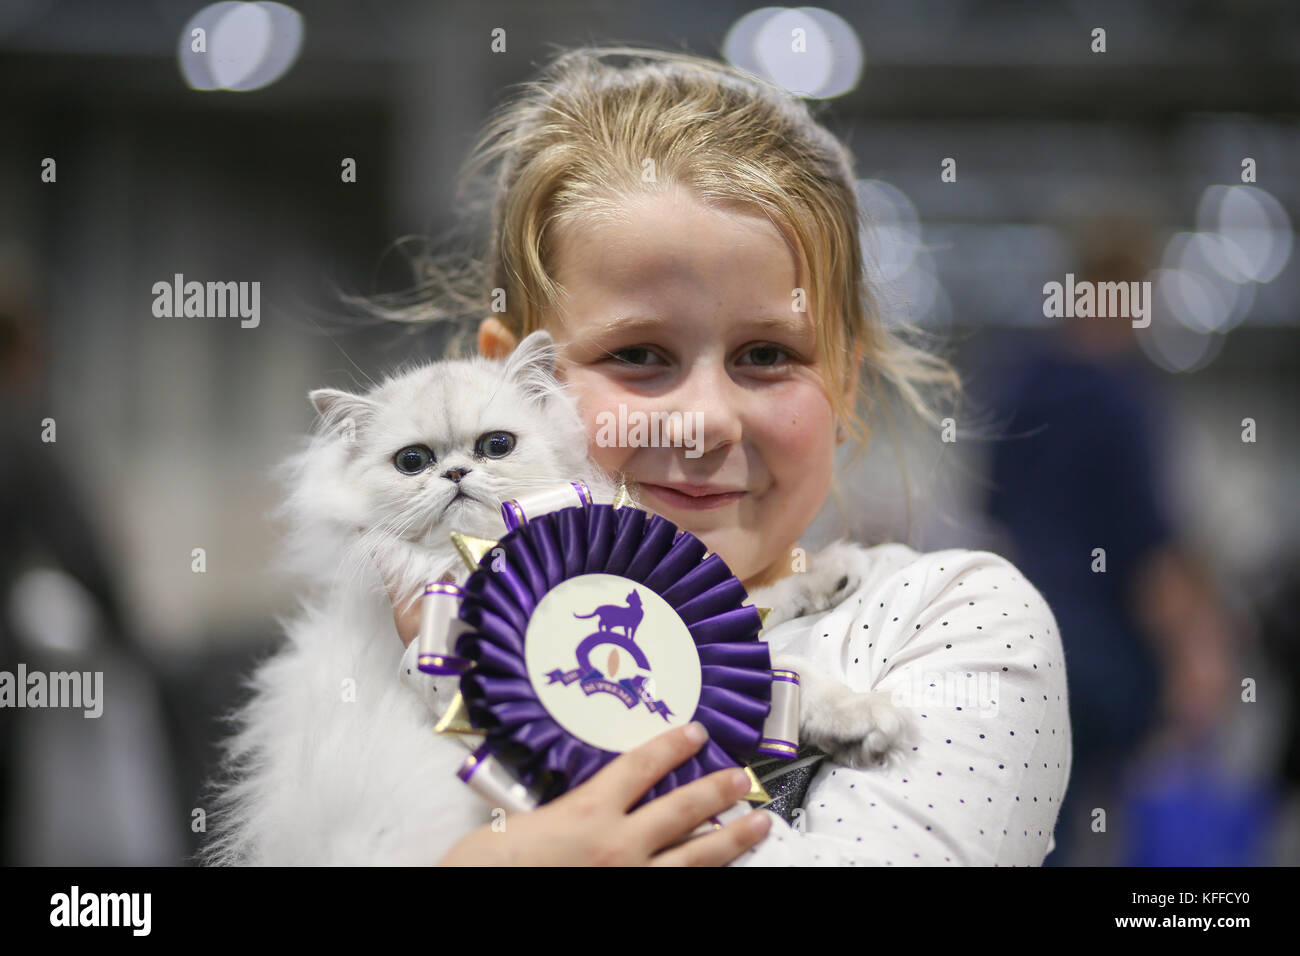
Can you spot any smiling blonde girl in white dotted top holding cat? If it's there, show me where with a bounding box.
[213,48,1070,866]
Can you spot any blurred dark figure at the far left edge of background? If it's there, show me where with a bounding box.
[0,246,179,865]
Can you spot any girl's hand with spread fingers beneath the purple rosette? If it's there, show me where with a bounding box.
[438,724,772,866]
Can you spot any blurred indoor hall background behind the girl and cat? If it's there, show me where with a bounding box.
[0,0,1300,865]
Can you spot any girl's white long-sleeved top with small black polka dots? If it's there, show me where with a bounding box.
[732,542,1071,866]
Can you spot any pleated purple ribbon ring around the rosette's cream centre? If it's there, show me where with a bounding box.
[455,505,772,805]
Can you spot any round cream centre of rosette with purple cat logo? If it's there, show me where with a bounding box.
[524,574,703,753]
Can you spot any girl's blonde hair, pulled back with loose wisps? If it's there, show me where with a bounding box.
[352,47,961,478]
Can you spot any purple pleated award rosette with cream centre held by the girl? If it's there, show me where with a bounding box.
[455,505,774,805]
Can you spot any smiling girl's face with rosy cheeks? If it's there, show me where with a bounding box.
[483,190,855,589]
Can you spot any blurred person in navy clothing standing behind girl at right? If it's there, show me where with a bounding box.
[987,202,1249,866]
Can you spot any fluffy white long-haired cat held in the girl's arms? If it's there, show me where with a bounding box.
[199,332,904,865]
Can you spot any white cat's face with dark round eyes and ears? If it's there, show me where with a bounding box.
[312,333,586,546]
